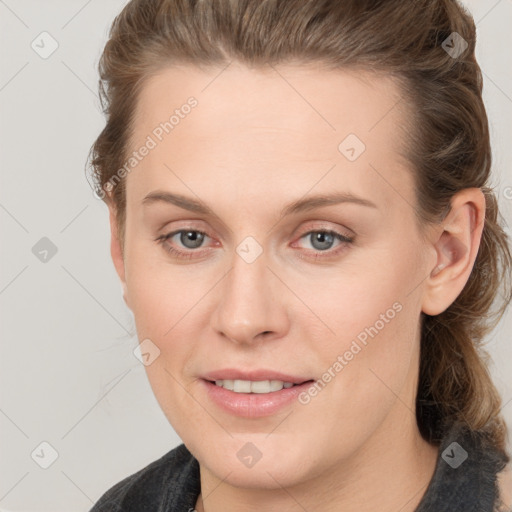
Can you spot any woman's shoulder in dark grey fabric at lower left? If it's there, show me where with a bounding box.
[90,444,200,512]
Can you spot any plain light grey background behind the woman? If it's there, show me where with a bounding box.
[0,0,512,512]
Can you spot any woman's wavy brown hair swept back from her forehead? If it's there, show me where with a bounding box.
[90,0,512,451]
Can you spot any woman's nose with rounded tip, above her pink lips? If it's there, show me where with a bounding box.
[211,246,289,345]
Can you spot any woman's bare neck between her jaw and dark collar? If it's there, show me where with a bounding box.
[196,412,438,512]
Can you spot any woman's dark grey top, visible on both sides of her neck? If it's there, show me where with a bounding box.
[90,427,509,512]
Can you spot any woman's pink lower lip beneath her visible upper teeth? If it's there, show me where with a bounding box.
[201,379,313,418]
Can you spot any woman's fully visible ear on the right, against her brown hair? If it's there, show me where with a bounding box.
[422,188,485,316]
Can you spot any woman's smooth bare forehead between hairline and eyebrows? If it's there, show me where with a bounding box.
[127,63,411,217]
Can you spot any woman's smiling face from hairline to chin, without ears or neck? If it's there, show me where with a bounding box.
[114,63,436,488]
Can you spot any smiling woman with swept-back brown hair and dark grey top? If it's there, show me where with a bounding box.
[87,0,512,512]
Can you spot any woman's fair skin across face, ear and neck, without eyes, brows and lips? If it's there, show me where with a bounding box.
[110,62,485,512]
